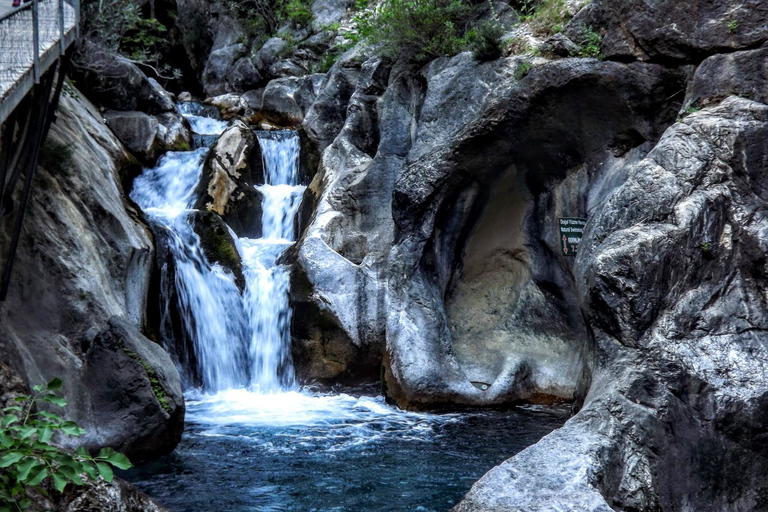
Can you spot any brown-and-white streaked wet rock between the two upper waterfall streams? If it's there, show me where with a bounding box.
[195,121,263,238]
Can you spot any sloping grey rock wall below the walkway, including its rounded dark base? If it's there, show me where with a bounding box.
[0,89,184,462]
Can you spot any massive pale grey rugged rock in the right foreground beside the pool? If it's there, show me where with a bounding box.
[455,97,768,512]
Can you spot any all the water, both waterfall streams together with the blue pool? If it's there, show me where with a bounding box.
[122,104,566,512]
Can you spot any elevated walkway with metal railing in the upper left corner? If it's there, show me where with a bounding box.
[0,0,80,123]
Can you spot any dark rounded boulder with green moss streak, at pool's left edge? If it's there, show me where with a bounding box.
[84,317,185,463]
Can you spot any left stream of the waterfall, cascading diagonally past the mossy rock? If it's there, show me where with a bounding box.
[131,126,248,390]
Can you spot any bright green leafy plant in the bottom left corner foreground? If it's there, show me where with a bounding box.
[0,379,132,512]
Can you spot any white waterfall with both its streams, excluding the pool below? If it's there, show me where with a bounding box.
[131,104,304,393]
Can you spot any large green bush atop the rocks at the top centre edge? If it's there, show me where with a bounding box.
[356,0,474,62]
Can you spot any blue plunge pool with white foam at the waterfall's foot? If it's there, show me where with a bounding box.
[123,390,567,512]
